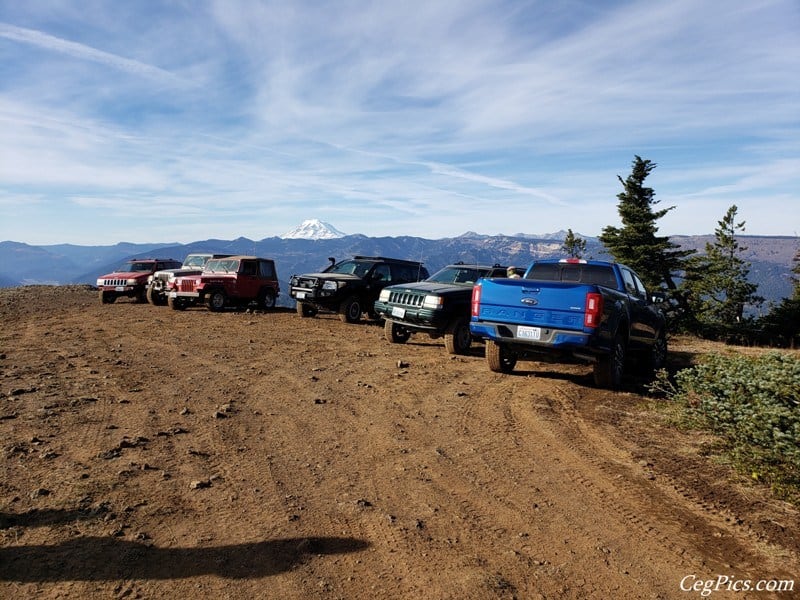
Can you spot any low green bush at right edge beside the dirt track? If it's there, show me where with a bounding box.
[670,352,800,498]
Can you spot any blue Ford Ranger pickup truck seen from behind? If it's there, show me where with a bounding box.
[470,258,667,388]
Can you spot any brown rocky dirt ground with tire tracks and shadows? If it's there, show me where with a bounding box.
[0,286,800,599]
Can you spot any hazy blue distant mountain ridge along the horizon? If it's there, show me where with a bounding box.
[0,232,800,301]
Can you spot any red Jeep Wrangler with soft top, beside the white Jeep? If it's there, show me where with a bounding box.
[167,256,280,311]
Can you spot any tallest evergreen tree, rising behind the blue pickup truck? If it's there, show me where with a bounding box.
[600,156,694,290]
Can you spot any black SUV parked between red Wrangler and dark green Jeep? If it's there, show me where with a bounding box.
[289,256,428,323]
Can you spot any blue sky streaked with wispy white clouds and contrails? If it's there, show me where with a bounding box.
[0,0,800,245]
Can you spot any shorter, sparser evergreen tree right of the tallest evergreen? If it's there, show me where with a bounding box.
[684,205,763,333]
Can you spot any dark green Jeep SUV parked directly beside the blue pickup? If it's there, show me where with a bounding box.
[374,263,523,354]
